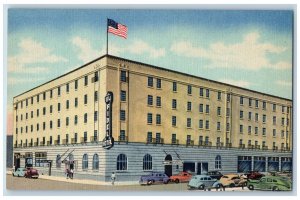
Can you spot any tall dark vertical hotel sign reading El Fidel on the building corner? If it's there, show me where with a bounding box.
[102,92,114,149]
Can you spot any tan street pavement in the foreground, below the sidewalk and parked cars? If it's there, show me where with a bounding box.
[6,175,249,193]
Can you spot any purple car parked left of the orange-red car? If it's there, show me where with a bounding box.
[139,172,170,185]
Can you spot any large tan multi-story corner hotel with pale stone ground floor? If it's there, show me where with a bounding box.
[13,55,293,181]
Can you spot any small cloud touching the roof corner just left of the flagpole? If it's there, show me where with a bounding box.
[71,36,101,63]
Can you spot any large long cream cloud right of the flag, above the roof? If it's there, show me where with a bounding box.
[170,32,291,70]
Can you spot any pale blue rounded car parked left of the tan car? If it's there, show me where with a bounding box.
[188,175,221,190]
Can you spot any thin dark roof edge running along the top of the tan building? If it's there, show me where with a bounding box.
[14,54,292,101]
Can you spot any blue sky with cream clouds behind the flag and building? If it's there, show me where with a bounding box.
[7,9,293,134]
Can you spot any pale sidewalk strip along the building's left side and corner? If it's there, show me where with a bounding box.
[6,171,139,186]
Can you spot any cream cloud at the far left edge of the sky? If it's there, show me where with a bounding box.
[8,38,68,74]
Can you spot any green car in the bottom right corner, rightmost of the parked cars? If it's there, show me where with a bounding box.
[247,176,292,191]
